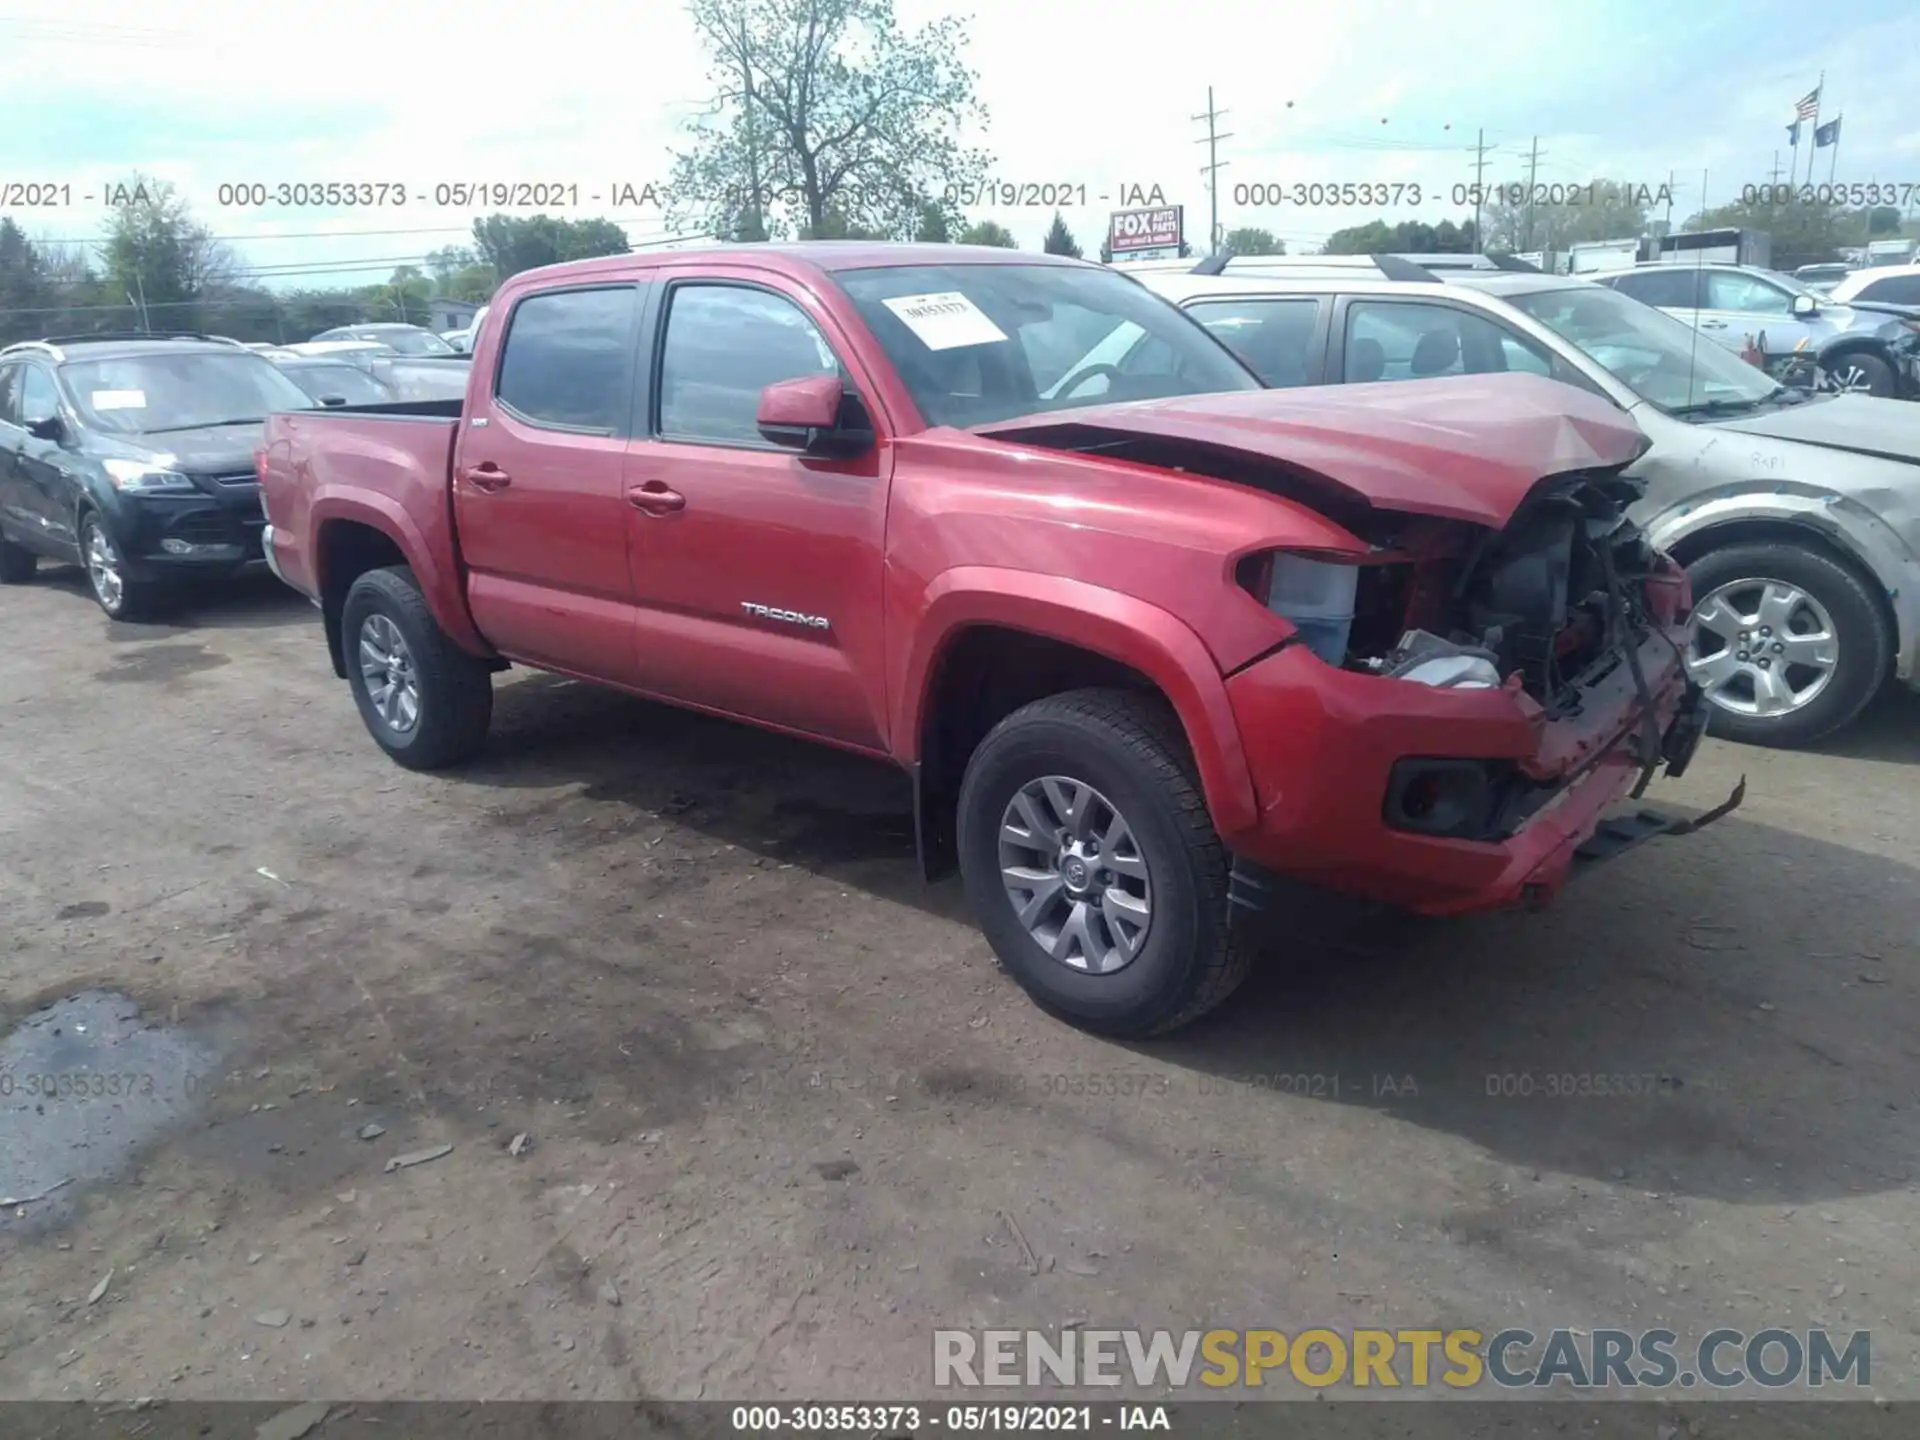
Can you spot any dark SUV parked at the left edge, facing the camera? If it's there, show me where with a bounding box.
[0,334,317,620]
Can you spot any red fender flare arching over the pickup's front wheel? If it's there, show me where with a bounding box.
[893,566,1260,835]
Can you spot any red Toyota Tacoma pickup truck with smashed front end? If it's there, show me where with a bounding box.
[247,242,1738,1035]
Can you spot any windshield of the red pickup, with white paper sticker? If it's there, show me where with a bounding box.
[835,265,1260,426]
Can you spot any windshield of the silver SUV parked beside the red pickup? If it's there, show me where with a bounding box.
[1507,286,1782,413]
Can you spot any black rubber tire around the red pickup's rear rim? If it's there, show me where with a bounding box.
[340,564,493,770]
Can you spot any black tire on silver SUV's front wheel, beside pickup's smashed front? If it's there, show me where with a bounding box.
[1688,543,1893,749]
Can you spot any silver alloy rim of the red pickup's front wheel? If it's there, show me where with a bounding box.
[1000,776,1154,975]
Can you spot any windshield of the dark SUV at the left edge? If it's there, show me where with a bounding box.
[60,349,313,436]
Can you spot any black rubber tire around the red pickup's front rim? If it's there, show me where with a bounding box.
[958,689,1254,1039]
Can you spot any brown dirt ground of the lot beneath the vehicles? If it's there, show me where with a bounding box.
[0,572,1920,1400]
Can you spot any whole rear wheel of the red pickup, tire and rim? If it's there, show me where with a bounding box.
[340,566,493,770]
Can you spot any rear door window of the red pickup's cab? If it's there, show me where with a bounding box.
[493,284,639,436]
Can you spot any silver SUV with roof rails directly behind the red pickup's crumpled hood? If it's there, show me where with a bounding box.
[1098,255,1920,745]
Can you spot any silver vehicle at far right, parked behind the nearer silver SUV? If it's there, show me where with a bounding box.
[1594,263,1920,399]
